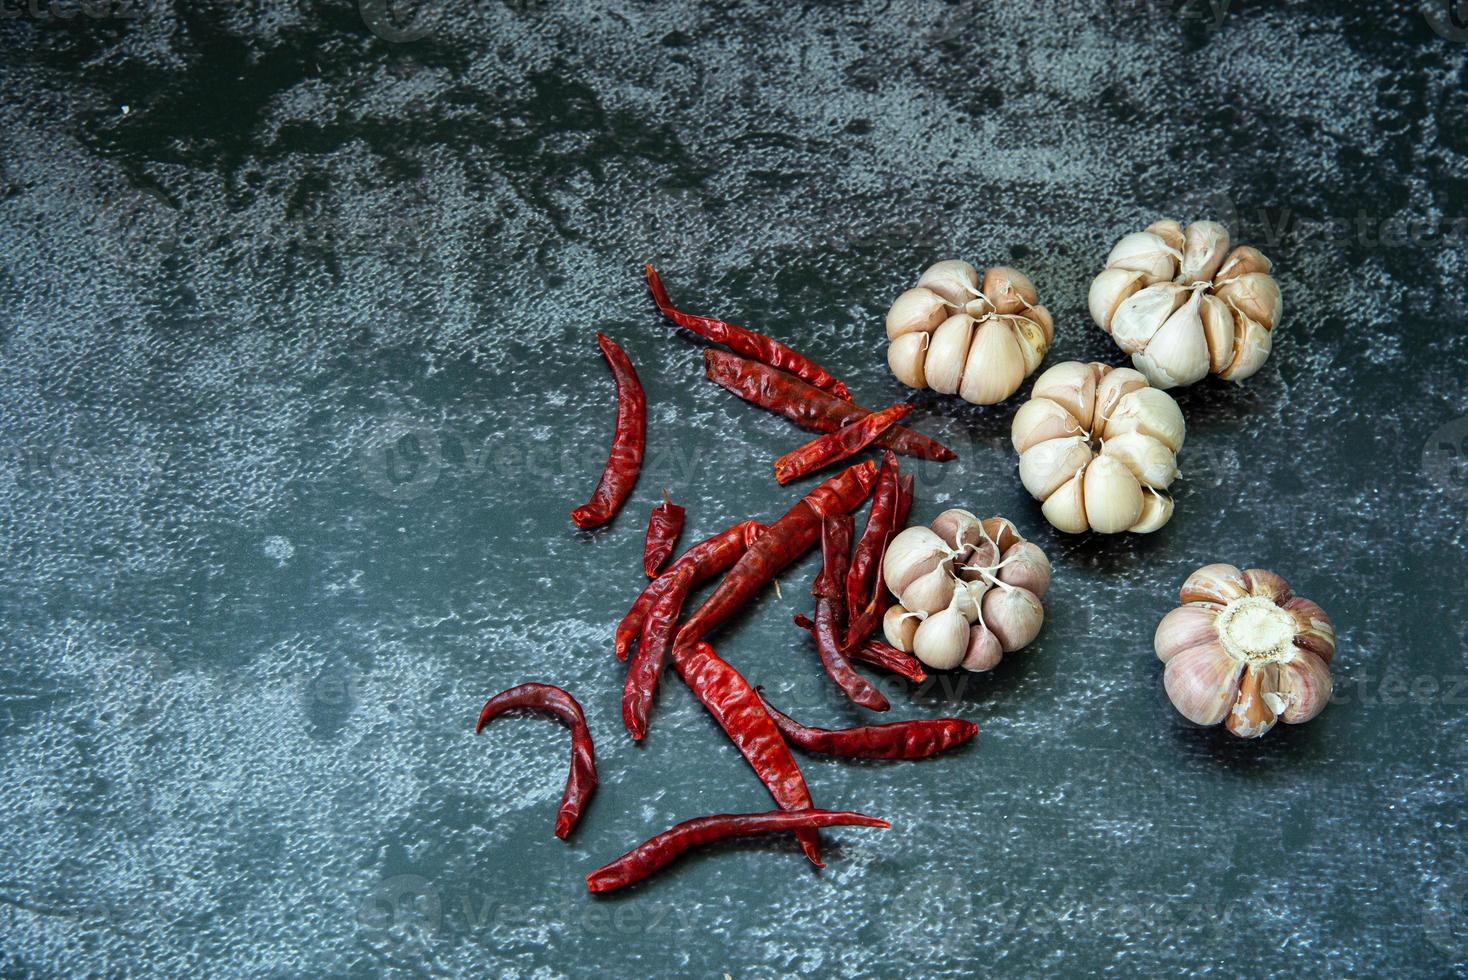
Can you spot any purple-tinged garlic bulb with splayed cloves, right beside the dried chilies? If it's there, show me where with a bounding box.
[882,510,1051,670]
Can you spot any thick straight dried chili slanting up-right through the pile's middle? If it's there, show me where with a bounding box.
[674,461,876,647]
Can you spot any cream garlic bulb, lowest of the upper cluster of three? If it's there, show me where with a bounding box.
[1010,361,1186,534]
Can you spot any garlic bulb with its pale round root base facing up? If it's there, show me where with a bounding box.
[1152,565,1336,738]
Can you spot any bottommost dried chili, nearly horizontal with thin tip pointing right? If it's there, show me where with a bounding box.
[586,810,893,892]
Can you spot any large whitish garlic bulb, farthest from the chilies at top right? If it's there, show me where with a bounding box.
[1088,222,1282,389]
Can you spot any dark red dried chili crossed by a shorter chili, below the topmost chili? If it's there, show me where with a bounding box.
[703,348,959,462]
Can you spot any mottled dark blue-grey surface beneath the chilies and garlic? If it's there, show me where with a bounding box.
[0,0,1468,977]
